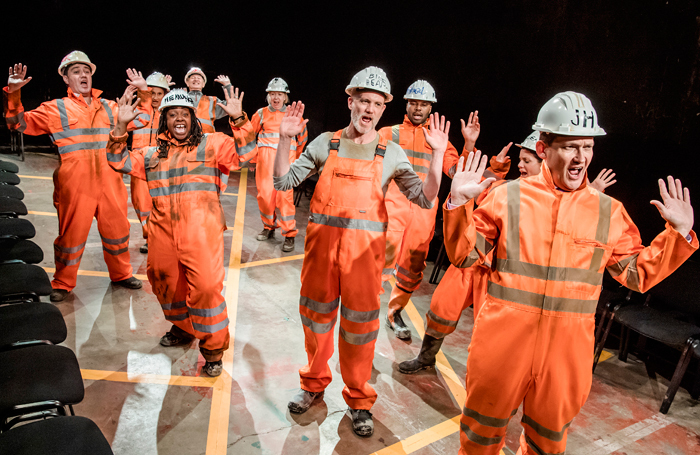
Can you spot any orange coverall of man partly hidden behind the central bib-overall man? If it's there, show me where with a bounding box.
[379,115,459,286]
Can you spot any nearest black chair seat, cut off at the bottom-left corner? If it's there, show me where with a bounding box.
[0,416,113,455]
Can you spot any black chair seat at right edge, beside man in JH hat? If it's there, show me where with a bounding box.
[615,305,700,349]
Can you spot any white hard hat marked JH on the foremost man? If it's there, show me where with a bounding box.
[532,92,606,137]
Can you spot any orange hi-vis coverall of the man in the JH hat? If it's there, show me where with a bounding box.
[444,163,698,455]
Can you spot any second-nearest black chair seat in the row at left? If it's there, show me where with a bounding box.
[0,344,85,416]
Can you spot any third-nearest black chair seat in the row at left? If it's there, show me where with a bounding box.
[0,302,67,347]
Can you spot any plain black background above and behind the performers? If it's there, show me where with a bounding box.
[5,0,700,243]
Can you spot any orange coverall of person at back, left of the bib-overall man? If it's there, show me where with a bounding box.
[232,106,309,237]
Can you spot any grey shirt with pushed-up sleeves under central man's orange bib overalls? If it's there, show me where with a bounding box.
[273,131,433,209]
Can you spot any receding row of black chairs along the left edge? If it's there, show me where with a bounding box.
[0,161,112,454]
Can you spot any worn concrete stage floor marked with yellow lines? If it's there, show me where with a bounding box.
[8,153,700,455]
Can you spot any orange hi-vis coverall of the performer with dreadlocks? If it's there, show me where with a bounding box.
[109,128,239,362]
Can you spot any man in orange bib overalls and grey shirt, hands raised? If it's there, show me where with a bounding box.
[274,66,449,436]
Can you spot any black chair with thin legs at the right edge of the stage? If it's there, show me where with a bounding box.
[593,260,700,414]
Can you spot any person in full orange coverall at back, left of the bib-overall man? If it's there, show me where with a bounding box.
[232,77,309,252]
